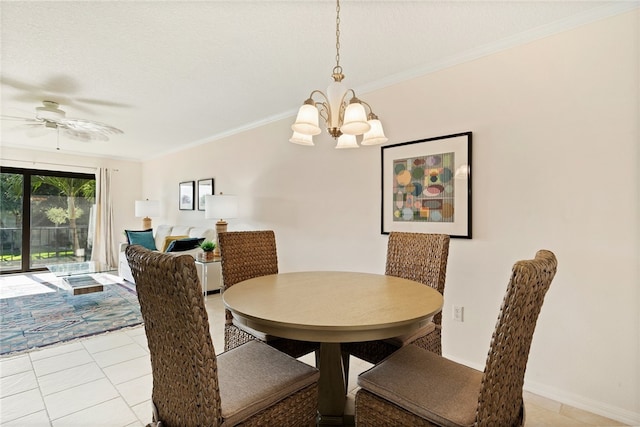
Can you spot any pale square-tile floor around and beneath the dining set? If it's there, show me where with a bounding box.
[0,294,623,427]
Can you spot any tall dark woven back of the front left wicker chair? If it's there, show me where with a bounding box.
[126,245,222,427]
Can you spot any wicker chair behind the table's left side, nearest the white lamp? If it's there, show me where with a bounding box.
[218,230,320,358]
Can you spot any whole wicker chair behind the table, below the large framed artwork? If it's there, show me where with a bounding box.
[342,232,449,364]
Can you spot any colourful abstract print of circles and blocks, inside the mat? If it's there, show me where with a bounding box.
[393,153,455,222]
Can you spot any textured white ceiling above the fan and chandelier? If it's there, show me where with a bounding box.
[0,0,638,159]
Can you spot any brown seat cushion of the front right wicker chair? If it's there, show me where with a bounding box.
[358,345,482,427]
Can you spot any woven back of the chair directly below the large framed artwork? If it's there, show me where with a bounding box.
[385,232,449,325]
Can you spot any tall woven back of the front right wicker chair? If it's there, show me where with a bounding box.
[477,250,558,426]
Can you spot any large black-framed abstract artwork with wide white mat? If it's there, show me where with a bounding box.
[381,132,471,239]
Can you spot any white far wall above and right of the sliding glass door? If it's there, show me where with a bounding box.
[0,147,142,257]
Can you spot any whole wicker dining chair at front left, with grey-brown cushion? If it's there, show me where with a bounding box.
[126,245,319,427]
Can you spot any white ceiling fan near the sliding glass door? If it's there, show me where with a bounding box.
[1,101,123,141]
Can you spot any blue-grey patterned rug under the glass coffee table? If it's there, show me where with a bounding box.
[0,274,142,355]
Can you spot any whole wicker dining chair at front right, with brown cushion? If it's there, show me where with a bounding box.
[356,250,557,427]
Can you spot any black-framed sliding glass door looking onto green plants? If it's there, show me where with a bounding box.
[0,168,96,273]
